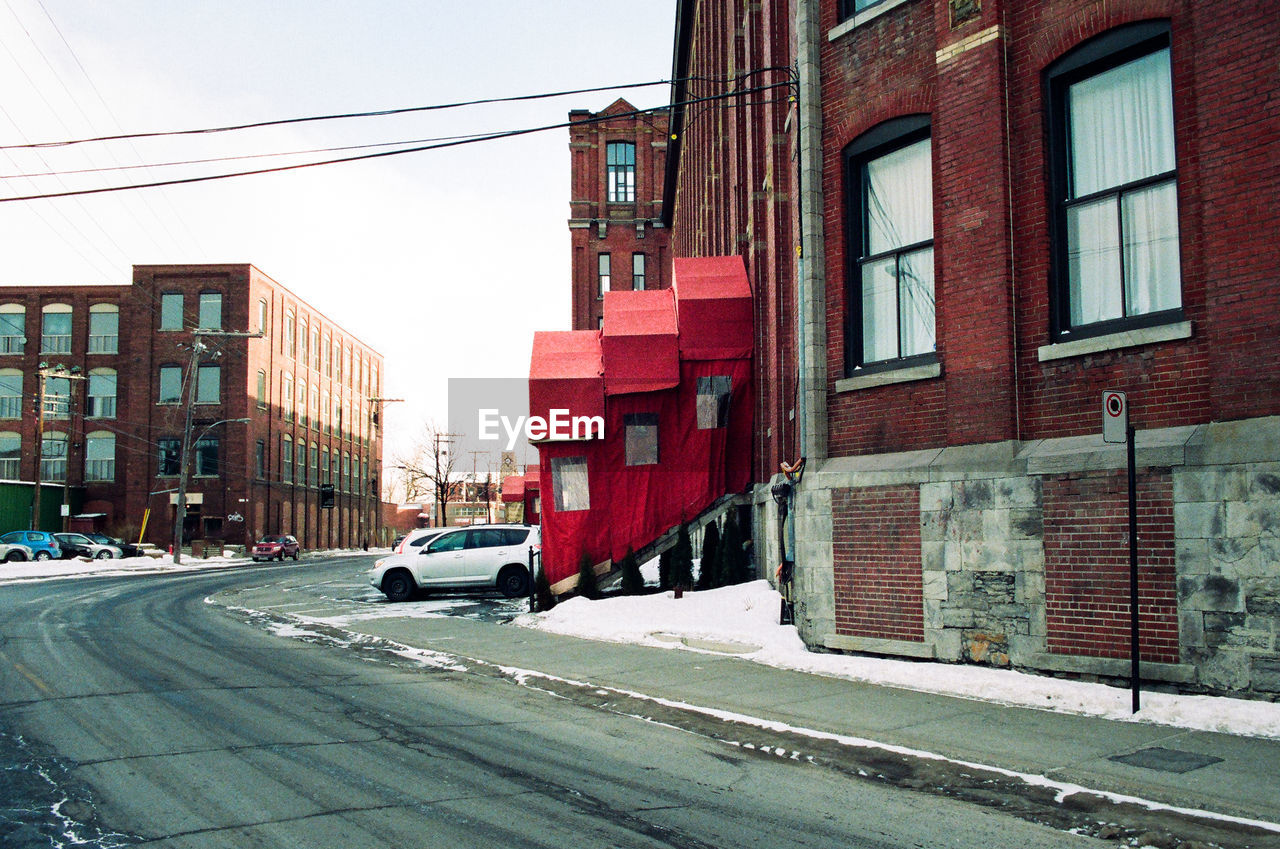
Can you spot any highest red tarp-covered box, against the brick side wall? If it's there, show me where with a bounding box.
[672,256,754,360]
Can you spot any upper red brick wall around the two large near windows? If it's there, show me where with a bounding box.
[820,0,1280,456]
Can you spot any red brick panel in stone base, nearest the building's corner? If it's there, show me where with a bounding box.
[832,487,924,642]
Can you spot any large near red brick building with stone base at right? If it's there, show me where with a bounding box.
[666,0,1280,697]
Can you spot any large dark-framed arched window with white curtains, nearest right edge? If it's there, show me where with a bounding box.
[1046,20,1183,342]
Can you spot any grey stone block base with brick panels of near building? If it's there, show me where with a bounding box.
[794,417,1280,699]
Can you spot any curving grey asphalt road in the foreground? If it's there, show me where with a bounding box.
[0,558,1105,849]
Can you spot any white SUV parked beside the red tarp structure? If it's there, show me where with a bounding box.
[369,525,541,602]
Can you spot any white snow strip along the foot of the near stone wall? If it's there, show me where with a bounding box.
[516,580,1280,738]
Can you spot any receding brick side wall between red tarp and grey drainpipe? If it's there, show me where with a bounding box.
[663,0,808,483]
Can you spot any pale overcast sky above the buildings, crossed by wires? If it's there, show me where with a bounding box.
[0,0,675,491]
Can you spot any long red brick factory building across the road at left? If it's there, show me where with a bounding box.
[0,265,383,558]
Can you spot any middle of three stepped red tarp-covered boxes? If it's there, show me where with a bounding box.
[600,289,680,394]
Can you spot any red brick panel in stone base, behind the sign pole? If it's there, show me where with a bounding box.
[1043,469,1179,663]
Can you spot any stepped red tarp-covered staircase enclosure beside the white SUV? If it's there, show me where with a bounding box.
[526,257,754,592]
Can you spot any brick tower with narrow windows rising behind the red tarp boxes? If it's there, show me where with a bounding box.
[568,100,671,330]
